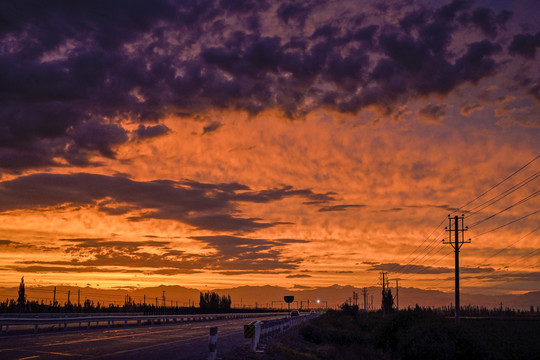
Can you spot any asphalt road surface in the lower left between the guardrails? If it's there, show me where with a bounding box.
[0,314,283,360]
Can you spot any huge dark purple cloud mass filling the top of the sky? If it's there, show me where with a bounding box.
[0,0,539,171]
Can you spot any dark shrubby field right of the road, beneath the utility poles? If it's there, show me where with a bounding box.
[224,309,540,360]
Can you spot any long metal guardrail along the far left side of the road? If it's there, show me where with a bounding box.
[0,313,276,335]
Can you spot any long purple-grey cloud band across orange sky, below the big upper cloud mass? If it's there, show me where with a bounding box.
[0,173,331,232]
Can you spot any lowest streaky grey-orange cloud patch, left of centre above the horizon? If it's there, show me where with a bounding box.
[13,235,307,275]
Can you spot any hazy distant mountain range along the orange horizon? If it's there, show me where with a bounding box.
[0,285,540,309]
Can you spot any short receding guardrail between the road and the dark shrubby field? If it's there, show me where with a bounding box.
[244,314,318,351]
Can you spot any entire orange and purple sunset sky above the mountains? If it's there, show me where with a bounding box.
[0,0,540,293]
